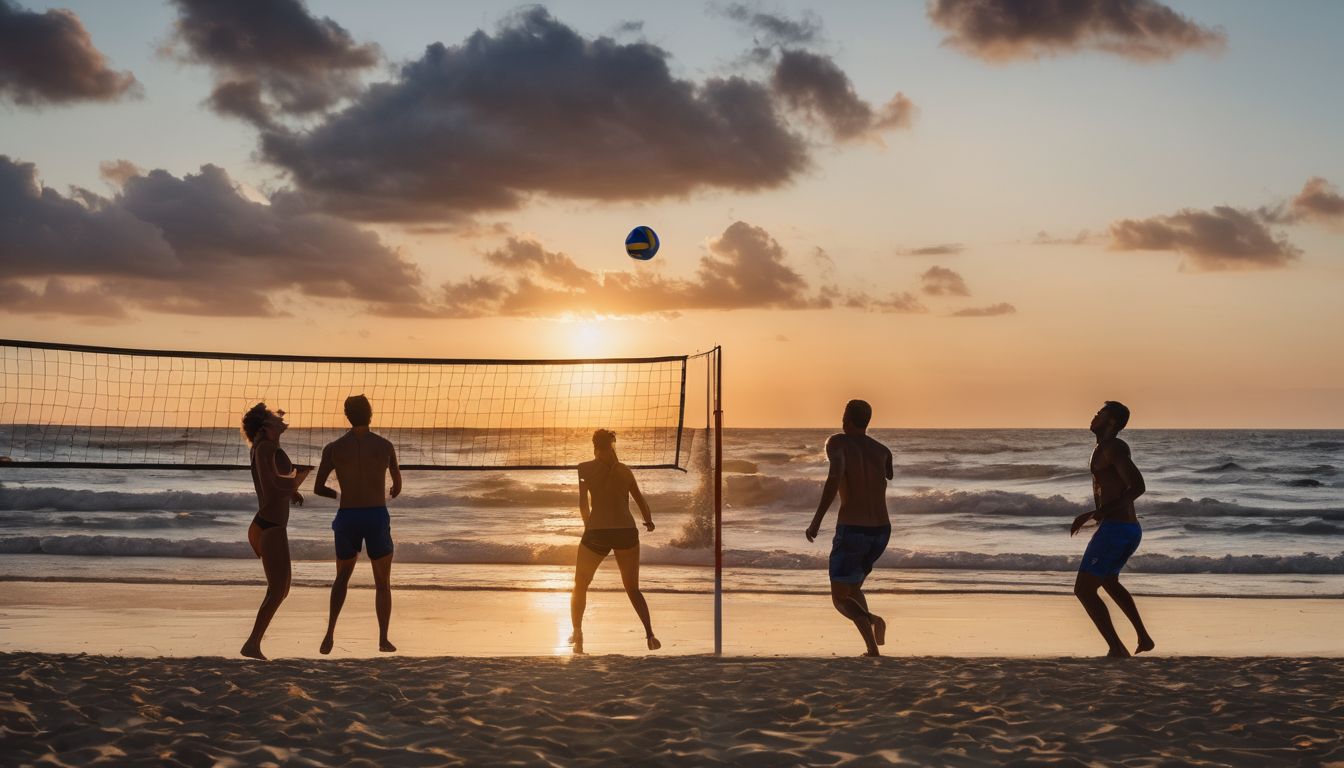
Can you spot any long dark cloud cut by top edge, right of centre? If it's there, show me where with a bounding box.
[929,0,1227,62]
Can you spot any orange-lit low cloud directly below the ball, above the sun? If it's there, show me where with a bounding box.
[408,222,832,317]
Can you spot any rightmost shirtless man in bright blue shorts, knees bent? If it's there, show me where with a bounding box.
[1068,401,1154,656]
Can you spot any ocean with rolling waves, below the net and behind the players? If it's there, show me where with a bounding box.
[0,429,1344,599]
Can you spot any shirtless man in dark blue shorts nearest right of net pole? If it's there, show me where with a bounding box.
[805,399,894,656]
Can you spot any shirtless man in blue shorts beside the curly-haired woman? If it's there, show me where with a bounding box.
[313,394,402,654]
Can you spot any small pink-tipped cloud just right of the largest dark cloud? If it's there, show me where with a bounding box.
[770,48,914,141]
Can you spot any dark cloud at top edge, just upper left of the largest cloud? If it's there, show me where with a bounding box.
[172,0,379,126]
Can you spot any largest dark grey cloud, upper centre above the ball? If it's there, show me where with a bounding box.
[261,8,860,222]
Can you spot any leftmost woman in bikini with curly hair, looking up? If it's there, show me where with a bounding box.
[241,402,312,659]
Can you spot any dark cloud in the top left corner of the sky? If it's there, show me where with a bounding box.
[0,0,141,106]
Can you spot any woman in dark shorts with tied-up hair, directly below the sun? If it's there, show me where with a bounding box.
[570,429,663,654]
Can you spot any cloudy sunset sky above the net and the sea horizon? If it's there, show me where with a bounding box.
[0,0,1344,428]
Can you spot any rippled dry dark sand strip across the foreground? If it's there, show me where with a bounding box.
[0,654,1344,767]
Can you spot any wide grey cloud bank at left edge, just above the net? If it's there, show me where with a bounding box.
[0,156,421,316]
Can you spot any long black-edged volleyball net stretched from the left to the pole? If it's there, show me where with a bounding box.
[0,340,718,469]
